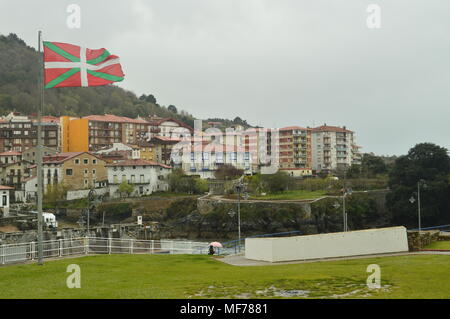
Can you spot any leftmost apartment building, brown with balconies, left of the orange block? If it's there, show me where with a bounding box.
[0,112,59,152]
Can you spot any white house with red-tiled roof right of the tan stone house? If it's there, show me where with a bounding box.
[106,159,172,197]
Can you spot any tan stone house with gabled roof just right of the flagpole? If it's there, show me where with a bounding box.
[43,152,108,190]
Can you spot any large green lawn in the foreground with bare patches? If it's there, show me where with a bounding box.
[0,255,450,298]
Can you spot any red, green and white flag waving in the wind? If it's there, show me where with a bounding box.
[43,41,124,89]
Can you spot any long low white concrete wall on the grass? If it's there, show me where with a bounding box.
[245,227,408,262]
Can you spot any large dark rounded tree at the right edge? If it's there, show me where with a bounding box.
[386,143,450,227]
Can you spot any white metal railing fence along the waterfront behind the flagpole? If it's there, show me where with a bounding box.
[0,237,209,265]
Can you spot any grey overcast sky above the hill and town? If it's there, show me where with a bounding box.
[0,0,450,154]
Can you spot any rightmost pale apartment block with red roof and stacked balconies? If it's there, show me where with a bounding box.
[311,124,360,172]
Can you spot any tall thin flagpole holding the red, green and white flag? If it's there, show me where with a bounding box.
[36,31,44,265]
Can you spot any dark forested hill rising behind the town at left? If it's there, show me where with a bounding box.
[0,34,199,126]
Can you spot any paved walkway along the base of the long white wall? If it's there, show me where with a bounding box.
[217,251,450,266]
